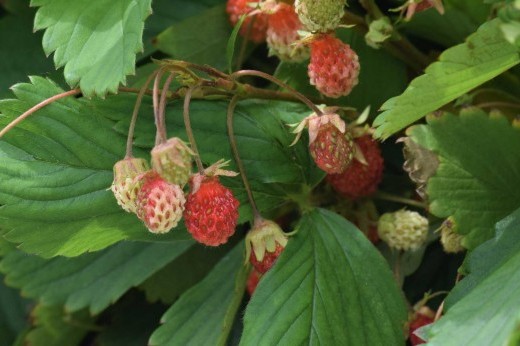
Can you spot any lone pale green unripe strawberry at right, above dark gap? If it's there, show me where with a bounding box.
[377,210,428,251]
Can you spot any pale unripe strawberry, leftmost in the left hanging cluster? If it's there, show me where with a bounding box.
[110,157,150,213]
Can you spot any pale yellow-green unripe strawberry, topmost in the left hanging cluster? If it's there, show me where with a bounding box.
[151,137,193,187]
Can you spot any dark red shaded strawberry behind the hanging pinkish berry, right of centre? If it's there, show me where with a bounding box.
[327,135,384,199]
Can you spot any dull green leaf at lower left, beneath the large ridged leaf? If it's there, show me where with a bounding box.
[0,241,193,314]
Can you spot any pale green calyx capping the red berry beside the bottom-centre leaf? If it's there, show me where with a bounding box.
[246,219,287,263]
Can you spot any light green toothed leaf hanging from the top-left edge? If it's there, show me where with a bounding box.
[31,0,151,97]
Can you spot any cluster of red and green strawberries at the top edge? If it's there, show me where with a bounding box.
[227,0,359,98]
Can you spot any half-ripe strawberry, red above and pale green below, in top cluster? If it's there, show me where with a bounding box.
[267,3,309,62]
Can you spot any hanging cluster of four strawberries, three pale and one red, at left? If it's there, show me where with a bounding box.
[111,138,239,246]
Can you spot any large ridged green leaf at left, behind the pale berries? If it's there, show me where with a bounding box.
[0,77,190,257]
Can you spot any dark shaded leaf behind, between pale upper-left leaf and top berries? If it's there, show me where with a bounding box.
[155,5,231,68]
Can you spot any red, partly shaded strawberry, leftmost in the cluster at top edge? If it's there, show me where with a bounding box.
[226,0,267,43]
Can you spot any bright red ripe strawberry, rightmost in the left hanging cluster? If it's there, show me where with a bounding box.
[184,175,239,246]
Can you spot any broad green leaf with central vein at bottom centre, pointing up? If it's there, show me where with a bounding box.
[241,209,407,345]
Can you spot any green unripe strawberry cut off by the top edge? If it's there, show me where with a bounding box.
[295,0,346,32]
